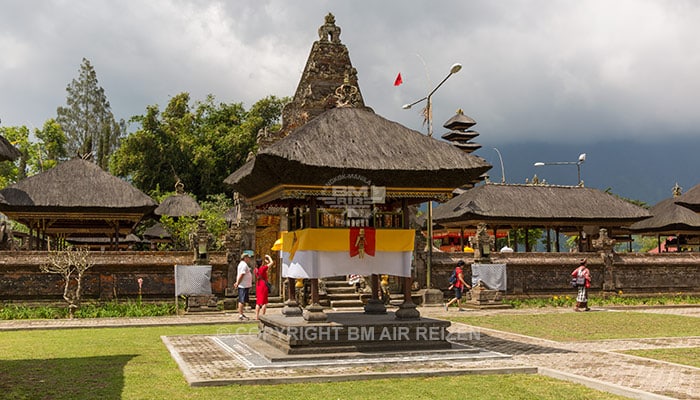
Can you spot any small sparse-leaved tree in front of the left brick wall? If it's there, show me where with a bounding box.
[39,249,94,318]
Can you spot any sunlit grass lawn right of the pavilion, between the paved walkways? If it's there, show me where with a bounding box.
[450,311,700,341]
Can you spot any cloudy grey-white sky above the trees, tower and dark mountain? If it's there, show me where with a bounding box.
[0,0,700,177]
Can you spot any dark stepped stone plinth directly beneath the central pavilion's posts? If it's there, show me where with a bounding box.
[258,312,454,355]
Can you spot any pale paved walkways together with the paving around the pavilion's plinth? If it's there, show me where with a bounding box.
[0,307,700,400]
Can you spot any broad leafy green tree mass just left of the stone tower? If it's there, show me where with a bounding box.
[110,93,288,199]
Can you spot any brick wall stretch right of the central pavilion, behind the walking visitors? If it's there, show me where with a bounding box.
[416,253,700,295]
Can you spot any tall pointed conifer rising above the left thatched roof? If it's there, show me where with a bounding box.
[56,58,125,169]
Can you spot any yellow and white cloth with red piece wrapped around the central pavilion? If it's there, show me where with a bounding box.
[282,228,415,278]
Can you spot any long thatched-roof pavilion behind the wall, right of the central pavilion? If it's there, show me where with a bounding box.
[433,183,651,252]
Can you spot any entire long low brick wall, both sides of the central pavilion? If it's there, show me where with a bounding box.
[0,251,700,301]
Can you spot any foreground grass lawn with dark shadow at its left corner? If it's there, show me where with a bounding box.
[0,325,621,400]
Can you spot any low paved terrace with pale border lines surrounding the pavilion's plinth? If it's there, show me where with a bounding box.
[162,334,520,386]
